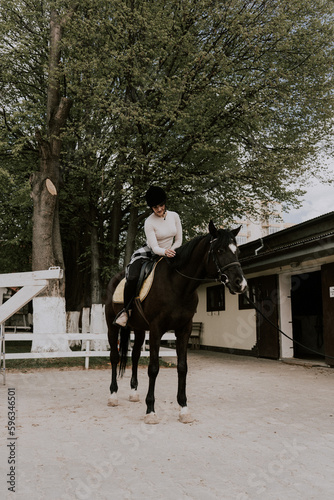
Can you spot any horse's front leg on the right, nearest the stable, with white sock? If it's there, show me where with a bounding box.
[175,324,194,424]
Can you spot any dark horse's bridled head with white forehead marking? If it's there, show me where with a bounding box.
[208,221,247,294]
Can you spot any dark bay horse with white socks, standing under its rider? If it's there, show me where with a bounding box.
[106,221,247,424]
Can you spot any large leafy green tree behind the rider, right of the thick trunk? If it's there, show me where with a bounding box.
[62,0,333,284]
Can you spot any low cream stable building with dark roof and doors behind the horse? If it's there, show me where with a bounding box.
[194,212,334,366]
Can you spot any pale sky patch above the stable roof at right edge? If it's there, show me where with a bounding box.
[283,158,334,224]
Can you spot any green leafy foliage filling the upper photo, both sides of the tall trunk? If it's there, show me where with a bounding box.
[0,0,334,300]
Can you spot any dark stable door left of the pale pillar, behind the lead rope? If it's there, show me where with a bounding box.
[252,275,280,359]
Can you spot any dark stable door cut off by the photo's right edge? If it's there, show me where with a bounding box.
[321,263,334,366]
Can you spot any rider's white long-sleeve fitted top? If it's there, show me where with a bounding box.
[144,210,182,255]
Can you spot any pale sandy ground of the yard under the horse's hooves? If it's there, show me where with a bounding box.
[0,351,334,500]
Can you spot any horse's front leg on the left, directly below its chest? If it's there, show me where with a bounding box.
[144,330,160,424]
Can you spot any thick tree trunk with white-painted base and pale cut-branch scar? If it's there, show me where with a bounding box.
[30,7,71,351]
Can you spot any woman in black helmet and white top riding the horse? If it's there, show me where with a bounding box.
[114,186,182,327]
